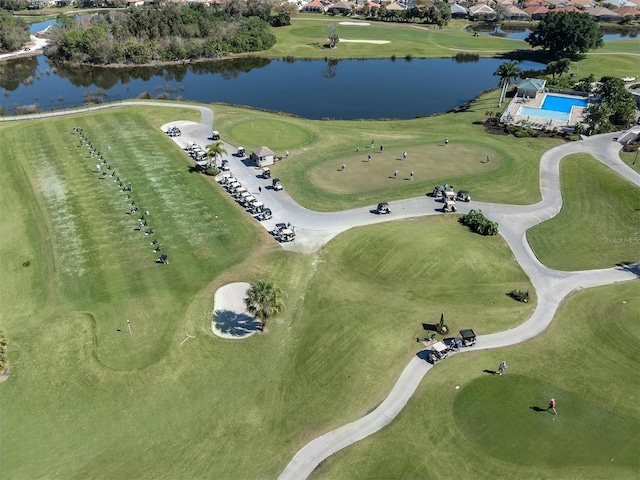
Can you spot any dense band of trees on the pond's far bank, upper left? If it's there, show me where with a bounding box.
[46,0,290,65]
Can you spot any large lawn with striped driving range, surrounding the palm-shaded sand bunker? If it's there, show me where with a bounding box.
[0,106,531,479]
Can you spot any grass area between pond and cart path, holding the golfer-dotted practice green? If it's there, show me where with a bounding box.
[215,92,562,211]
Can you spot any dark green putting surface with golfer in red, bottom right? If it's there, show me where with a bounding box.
[453,376,640,467]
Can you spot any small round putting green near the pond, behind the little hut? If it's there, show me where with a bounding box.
[228,117,314,155]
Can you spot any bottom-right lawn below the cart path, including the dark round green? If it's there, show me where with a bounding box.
[313,282,640,479]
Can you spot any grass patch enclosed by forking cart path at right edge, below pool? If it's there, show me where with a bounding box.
[527,154,640,270]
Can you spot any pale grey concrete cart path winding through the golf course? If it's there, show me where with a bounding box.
[5,101,640,480]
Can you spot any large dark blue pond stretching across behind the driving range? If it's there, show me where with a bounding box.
[0,56,544,120]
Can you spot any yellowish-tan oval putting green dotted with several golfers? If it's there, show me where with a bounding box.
[309,143,502,194]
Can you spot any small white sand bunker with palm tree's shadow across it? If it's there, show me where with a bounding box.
[211,282,261,339]
